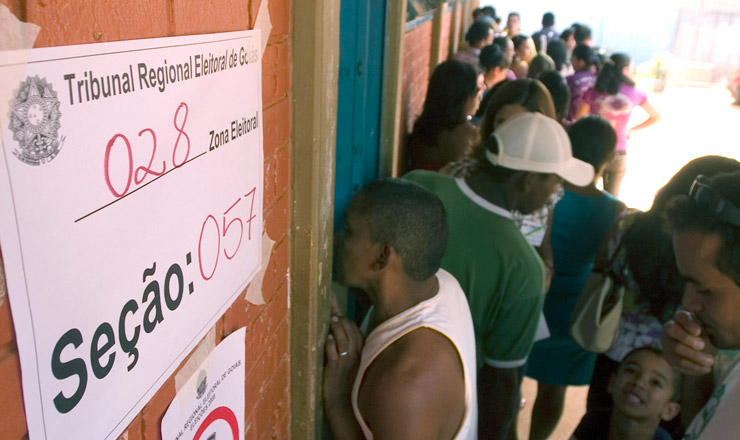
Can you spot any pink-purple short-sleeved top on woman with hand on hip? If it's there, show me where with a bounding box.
[583,83,647,152]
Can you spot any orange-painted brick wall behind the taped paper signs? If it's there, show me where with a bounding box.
[0,0,292,440]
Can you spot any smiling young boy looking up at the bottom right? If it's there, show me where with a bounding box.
[572,347,681,440]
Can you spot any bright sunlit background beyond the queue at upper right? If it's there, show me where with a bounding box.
[481,0,740,213]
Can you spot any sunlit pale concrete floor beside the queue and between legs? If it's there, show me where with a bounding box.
[517,83,740,440]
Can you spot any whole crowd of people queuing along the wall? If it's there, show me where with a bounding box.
[323,7,740,440]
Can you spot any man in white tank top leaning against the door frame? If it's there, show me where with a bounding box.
[324,179,478,440]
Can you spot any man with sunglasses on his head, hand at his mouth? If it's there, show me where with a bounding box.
[663,173,740,440]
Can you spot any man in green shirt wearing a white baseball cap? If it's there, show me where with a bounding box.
[405,112,594,439]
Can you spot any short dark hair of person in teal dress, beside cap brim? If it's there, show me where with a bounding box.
[568,115,617,172]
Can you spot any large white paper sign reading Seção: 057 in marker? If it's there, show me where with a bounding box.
[0,31,263,439]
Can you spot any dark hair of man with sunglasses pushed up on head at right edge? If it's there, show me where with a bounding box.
[665,171,740,286]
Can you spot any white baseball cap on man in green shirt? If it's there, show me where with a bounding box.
[486,112,594,186]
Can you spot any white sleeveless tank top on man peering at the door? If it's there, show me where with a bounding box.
[352,269,478,440]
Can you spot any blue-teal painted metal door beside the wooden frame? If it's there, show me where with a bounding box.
[334,0,387,229]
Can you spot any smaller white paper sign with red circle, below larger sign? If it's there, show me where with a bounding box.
[162,327,246,440]
